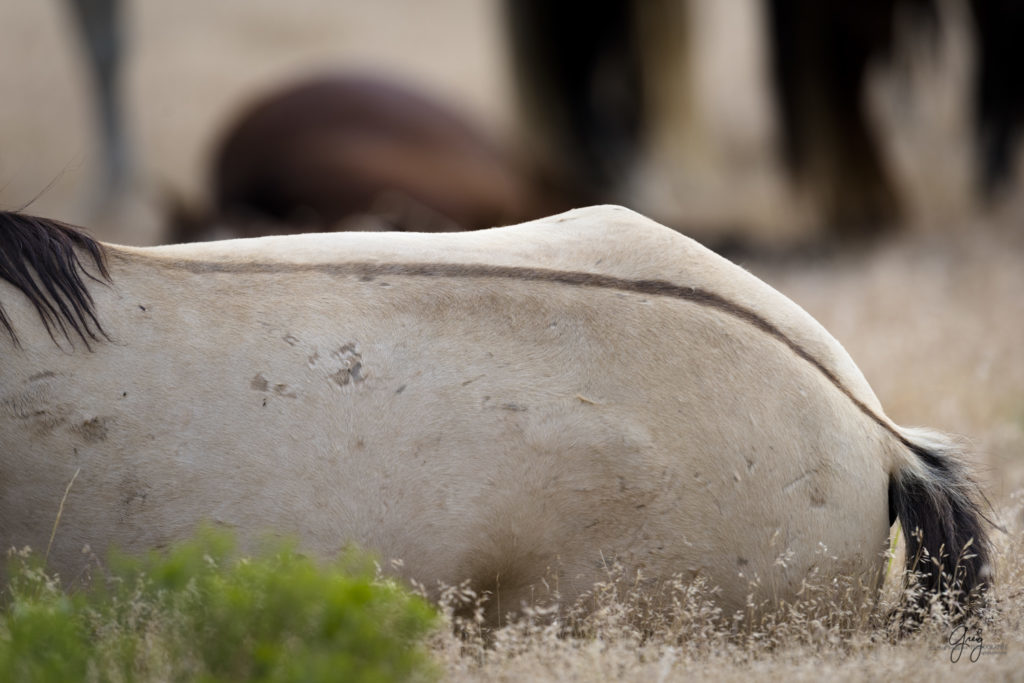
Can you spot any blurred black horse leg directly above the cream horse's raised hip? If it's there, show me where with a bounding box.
[505,0,644,209]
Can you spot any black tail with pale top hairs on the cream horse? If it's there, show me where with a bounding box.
[889,428,993,614]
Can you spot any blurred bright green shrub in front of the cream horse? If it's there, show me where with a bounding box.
[0,530,437,681]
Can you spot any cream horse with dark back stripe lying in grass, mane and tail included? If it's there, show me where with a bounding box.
[0,207,987,613]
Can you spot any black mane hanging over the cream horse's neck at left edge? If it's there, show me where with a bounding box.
[0,211,110,348]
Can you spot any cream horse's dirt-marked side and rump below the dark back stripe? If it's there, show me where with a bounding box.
[0,254,888,608]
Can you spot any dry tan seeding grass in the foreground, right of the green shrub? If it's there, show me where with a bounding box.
[433,501,1024,681]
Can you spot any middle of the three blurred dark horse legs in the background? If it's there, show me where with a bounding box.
[768,0,919,238]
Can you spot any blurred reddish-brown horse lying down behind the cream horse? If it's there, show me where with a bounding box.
[170,76,567,242]
